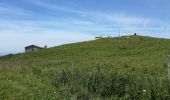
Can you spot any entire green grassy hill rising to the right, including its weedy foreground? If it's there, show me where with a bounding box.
[0,36,170,100]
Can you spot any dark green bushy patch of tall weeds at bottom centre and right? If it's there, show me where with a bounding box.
[54,66,170,100]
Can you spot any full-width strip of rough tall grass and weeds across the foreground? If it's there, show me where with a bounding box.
[0,62,170,100]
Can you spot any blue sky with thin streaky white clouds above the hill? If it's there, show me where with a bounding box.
[0,0,170,55]
